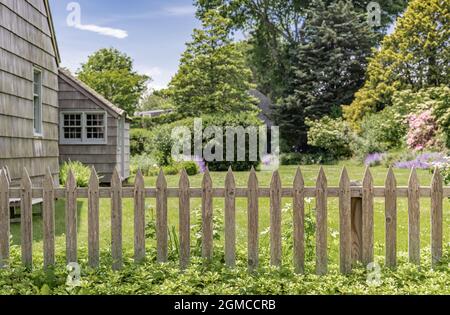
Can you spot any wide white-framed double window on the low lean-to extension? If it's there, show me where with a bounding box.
[61,112,106,144]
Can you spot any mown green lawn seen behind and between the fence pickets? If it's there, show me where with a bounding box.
[7,162,450,263]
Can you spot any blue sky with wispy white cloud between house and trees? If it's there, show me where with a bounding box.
[50,0,200,89]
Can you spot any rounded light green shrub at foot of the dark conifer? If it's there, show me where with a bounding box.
[306,116,353,159]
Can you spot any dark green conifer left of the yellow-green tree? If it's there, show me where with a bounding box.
[274,0,376,149]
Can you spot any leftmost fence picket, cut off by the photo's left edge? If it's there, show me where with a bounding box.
[0,170,10,268]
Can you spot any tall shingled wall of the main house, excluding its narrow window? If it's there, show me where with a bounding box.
[0,0,59,182]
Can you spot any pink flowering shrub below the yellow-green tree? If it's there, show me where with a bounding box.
[406,110,439,151]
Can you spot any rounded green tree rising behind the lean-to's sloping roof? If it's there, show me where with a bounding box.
[77,48,150,116]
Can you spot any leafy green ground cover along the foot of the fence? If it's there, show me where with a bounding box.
[0,199,450,295]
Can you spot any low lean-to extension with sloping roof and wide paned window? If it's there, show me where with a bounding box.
[58,69,130,183]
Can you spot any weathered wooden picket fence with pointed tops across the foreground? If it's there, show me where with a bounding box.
[0,168,444,275]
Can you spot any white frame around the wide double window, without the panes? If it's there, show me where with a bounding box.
[59,110,108,145]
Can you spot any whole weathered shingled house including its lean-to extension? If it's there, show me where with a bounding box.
[0,0,130,185]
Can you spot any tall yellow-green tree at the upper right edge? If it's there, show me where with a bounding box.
[344,0,450,129]
